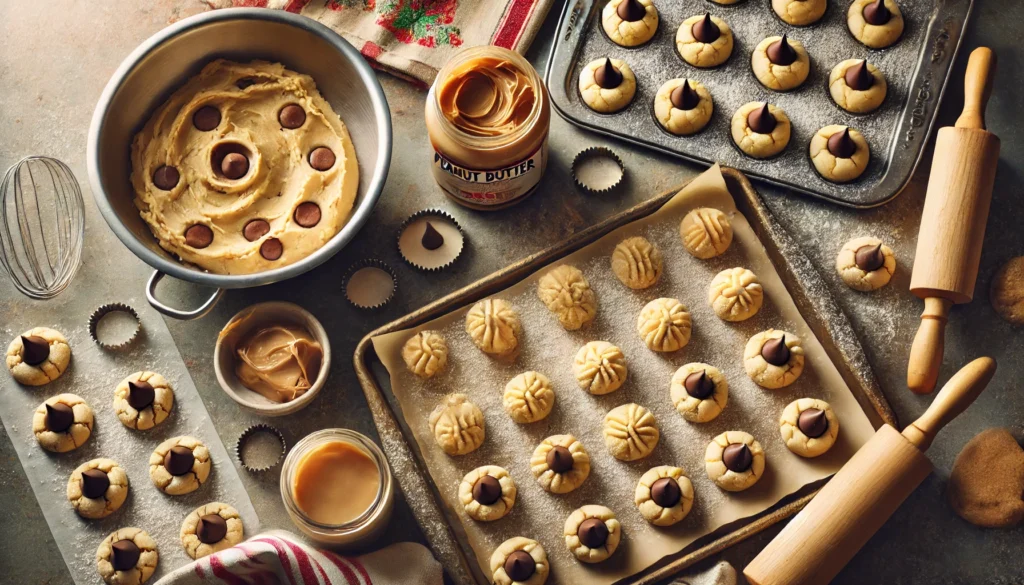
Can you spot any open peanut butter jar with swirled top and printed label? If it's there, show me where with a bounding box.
[426,46,551,209]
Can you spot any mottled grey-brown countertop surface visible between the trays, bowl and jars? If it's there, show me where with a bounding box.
[0,0,1024,584]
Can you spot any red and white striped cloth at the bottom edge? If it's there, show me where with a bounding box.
[157,531,442,585]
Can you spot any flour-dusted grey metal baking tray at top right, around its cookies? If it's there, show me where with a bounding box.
[545,0,974,208]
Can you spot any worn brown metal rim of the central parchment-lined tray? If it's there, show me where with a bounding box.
[354,168,897,585]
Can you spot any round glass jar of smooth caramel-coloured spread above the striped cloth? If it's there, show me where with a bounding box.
[281,428,394,545]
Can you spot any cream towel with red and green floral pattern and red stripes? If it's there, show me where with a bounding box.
[206,0,552,87]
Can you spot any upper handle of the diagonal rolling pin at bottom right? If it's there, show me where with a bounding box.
[903,358,995,451]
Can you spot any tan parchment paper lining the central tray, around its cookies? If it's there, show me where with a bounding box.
[373,166,874,584]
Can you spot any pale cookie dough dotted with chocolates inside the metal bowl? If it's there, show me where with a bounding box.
[131,59,358,275]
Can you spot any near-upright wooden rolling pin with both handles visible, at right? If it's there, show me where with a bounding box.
[906,47,999,393]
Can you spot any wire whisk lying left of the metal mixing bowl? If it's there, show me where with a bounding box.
[0,156,85,299]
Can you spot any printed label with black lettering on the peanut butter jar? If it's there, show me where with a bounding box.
[432,140,548,206]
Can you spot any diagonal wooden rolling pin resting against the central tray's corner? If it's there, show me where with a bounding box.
[743,358,995,585]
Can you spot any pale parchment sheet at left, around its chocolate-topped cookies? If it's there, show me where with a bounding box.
[0,305,259,585]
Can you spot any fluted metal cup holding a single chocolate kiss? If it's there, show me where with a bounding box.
[397,209,466,273]
